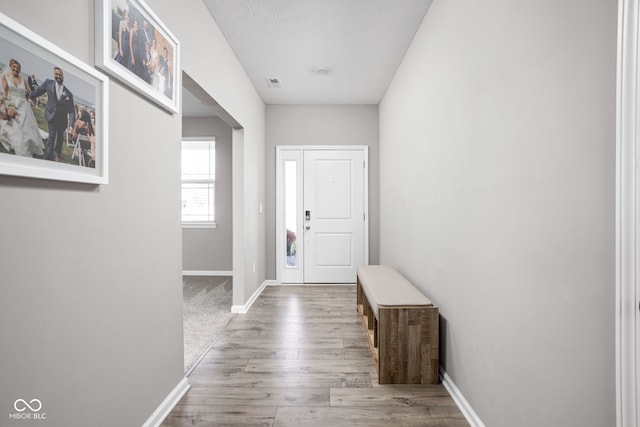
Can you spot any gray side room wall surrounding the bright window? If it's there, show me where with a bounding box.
[182,117,233,271]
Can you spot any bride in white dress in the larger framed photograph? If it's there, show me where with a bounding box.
[0,59,44,157]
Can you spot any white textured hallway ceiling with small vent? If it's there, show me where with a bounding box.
[203,0,431,104]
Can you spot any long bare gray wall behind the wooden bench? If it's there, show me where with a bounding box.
[380,0,617,427]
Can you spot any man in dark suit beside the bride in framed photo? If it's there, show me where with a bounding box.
[29,67,76,162]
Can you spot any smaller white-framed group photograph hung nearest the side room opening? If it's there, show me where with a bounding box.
[95,0,181,113]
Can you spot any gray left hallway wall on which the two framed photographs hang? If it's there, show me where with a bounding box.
[0,0,265,426]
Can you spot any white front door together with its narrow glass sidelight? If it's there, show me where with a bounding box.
[276,146,368,283]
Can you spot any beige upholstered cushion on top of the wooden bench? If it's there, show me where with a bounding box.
[358,265,433,317]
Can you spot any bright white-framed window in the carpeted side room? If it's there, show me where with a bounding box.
[182,139,216,227]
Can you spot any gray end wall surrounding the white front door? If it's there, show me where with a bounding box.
[265,105,380,279]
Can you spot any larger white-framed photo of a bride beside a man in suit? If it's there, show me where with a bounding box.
[0,13,109,184]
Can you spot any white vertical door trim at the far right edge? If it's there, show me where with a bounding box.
[615,0,640,427]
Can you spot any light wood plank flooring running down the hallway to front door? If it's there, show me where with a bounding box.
[162,285,468,427]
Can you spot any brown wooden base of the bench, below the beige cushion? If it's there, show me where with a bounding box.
[357,280,440,384]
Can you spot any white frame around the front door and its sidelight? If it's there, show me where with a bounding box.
[276,145,369,284]
